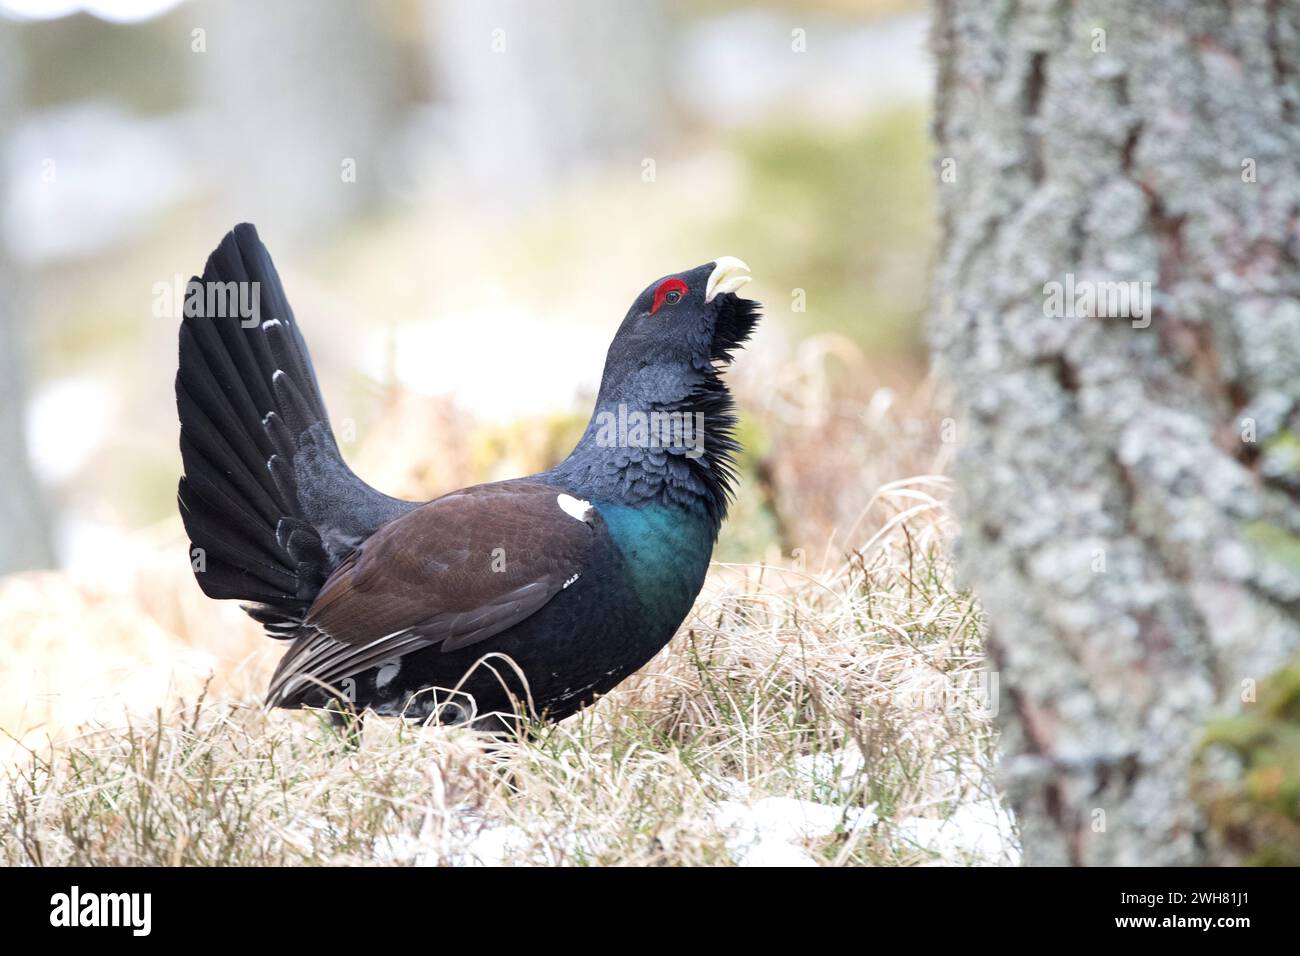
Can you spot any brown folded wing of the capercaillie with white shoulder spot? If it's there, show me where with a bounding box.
[268,481,602,704]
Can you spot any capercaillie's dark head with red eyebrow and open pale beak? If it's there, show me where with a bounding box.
[601,256,759,408]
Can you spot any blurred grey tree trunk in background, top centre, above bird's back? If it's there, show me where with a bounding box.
[426,0,675,206]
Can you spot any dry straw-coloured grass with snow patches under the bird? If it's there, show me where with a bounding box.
[0,479,1014,865]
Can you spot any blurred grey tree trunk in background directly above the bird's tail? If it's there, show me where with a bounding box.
[189,0,400,239]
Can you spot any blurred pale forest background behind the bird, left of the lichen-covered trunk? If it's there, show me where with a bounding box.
[0,0,943,754]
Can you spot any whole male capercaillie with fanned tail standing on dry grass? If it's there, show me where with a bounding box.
[176,224,759,730]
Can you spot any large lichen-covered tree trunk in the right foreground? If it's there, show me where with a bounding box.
[931,0,1300,865]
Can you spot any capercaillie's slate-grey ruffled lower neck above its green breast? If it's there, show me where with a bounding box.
[545,377,740,537]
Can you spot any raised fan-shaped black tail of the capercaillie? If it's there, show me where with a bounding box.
[176,224,413,637]
